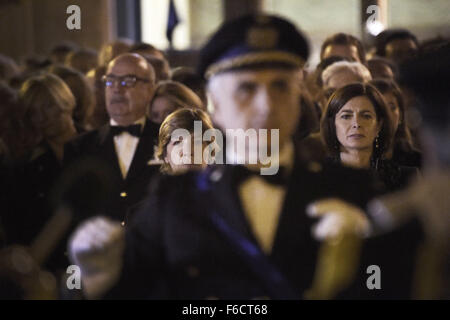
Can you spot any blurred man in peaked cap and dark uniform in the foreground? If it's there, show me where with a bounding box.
[69,15,382,299]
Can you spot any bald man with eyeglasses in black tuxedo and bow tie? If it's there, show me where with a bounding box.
[64,53,159,224]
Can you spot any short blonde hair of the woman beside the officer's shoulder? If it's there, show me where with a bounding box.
[156,108,214,173]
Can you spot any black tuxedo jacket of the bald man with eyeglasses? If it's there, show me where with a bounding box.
[64,119,159,221]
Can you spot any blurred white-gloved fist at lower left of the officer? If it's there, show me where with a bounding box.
[69,217,125,299]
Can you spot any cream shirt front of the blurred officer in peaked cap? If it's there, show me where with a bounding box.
[239,143,295,254]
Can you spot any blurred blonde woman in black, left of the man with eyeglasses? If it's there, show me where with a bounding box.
[8,74,76,251]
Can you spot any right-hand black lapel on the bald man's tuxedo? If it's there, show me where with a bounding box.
[126,119,159,180]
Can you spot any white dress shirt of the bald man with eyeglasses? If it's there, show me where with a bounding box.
[110,117,145,179]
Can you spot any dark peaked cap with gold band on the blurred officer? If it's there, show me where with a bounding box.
[198,16,309,78]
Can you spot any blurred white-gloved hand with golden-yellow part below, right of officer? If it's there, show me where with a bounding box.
[305,198,370,299]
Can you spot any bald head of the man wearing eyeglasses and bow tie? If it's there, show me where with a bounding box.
[105,53,155,125]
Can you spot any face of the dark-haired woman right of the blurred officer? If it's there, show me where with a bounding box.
[335,96,381,150]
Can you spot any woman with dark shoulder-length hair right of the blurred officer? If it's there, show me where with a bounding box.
[320,83,412,191]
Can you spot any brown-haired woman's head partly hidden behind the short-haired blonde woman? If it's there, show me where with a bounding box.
[149,81,205,124]
